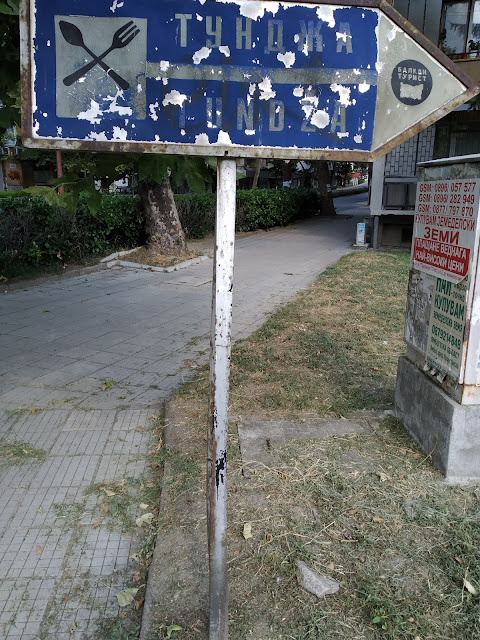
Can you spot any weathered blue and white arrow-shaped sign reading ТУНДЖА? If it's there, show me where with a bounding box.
[23,0,475,159]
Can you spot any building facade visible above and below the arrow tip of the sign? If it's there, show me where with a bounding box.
[370,0,480,248]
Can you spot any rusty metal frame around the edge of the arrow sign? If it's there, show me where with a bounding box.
[20,0,480,162]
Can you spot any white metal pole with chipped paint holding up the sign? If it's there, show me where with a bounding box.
[207,158,237,640]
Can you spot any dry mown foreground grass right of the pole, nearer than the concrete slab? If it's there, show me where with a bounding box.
[229,419,480,640]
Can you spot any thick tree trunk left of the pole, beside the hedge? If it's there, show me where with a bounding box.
[138,178,188,256]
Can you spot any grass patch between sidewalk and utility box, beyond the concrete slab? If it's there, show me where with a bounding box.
[230,253,409,416]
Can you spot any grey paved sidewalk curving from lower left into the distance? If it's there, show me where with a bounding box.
[0,212,357,640]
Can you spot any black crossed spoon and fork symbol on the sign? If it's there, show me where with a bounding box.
[59,20,140,91]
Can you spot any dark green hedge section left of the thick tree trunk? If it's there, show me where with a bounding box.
[0,192,144,274]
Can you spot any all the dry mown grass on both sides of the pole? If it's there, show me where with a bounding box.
[159,252,480,640]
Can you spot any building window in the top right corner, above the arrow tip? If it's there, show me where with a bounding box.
[439,0,480,58]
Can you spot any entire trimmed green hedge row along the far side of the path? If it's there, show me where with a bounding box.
[0,189,319,274]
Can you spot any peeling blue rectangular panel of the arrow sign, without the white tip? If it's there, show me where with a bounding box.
[34,0,378,149]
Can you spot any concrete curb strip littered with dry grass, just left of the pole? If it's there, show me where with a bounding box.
[140,397,208,640]
